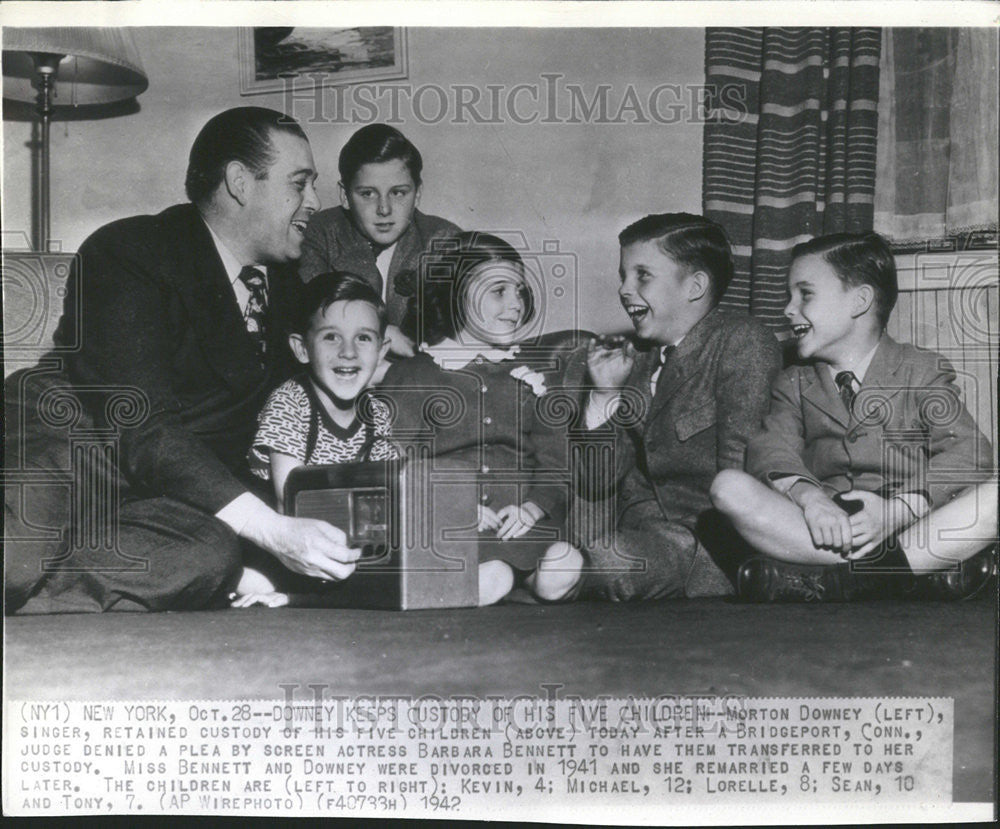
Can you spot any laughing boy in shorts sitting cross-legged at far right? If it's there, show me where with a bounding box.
[712,233,997,601]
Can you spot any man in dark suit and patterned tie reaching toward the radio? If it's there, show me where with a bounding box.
[5,107,358,613]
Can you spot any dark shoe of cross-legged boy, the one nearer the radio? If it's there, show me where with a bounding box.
[736,556,848,602]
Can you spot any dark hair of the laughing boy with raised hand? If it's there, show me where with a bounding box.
[618,213,733,305]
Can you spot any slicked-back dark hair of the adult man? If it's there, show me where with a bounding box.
[184,107,308,205]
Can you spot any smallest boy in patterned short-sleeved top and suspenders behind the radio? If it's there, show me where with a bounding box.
[233,272,397,607]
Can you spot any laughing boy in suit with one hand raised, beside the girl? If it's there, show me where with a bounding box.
[580,213,780,601]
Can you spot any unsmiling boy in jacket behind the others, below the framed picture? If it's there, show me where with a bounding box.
[299,124,460,357]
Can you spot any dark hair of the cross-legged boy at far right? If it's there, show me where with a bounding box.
[792,231,899,328]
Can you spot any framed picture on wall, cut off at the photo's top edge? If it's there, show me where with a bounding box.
[239,26,407,95]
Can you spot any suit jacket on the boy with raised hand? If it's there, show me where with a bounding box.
[588,308,781,529]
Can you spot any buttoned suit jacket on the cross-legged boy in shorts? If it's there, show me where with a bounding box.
[747,335,993,505]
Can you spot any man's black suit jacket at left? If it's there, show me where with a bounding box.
[47,204,301,513]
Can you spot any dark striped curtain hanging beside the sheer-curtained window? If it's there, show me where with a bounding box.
[702,28,881,329]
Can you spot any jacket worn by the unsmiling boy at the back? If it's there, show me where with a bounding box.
[299,207,461,325]
